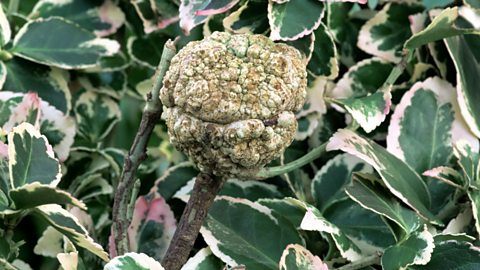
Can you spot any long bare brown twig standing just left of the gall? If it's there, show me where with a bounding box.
[110,40,176,257]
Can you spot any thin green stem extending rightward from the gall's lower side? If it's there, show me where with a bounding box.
[257,142,327,178]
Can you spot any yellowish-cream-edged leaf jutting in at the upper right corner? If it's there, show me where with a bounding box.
[404,7,480,49]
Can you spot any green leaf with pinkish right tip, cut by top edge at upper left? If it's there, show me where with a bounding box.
[31,0,125,36]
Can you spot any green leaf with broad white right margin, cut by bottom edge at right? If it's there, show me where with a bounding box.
[382,226,435,270]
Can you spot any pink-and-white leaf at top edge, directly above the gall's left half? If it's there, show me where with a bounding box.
[179,0,239,34]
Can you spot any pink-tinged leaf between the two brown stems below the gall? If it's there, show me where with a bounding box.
[128,193,176,260]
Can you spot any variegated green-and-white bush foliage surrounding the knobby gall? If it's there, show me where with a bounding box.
[0,0,480,270]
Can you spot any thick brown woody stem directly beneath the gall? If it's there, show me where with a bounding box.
[162,173,224,270]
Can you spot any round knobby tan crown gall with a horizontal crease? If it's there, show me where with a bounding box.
[160,32,307,179]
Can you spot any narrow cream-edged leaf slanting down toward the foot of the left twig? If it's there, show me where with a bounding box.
[34,204,108,261]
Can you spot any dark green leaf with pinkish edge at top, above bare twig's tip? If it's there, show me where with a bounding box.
[131,0,180,34]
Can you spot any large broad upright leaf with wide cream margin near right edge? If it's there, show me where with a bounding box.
[387,77,479,173]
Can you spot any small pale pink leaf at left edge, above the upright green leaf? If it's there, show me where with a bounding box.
[3,92,40,132]
